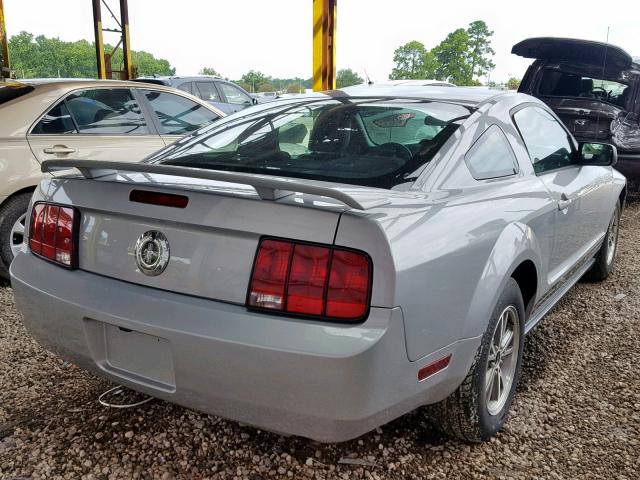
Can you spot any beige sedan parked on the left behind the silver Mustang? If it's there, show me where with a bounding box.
[0,79,224,278]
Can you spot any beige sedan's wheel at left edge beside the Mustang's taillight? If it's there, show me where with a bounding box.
[0,192,32,280]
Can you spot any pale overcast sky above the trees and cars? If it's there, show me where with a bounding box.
[4,0,640,81]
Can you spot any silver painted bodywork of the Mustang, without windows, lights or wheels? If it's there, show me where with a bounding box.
[12,87,625,441]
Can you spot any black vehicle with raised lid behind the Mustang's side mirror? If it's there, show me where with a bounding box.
[511,37,640,183]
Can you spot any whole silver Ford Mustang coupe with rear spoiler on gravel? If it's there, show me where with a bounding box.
[11,86,626,441]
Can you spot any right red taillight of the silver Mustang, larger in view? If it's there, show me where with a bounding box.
[247,239,372,322]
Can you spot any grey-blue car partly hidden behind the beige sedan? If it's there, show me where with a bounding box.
[134,75,260,114]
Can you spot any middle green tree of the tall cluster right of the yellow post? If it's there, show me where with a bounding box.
[433,28,473,85]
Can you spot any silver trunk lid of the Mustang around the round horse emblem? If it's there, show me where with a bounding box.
[42,173,346,304]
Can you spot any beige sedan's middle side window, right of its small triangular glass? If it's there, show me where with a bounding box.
[66,88,149,135]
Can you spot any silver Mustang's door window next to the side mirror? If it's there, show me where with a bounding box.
[513,107,574,173]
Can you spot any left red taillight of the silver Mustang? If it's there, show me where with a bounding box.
[29,203,79,268]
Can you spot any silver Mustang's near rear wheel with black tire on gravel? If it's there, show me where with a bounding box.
[426,278,525,442]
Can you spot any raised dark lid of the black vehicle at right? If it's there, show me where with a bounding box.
[511,37,633,70]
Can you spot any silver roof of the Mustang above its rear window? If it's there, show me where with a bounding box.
[338,85,509,107]
